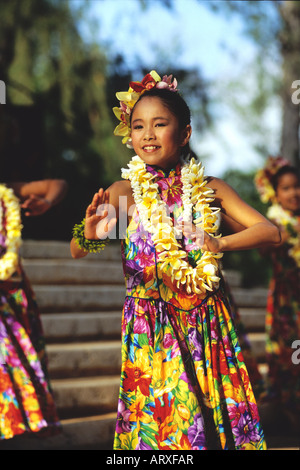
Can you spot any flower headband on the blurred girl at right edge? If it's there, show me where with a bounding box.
[254,157,290,203]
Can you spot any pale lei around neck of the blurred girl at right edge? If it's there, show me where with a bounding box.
[267,204,300,268]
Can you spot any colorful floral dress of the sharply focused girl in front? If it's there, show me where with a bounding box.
[114,165,266,450]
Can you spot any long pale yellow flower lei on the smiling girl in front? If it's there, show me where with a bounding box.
[122,155,223,297]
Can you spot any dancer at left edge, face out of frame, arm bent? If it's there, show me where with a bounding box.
[0,180,66,449]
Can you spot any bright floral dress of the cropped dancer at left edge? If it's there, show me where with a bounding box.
[0,194,60,440]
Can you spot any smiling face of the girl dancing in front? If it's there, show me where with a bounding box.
[131,96,191,170]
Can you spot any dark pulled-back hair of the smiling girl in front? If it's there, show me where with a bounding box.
[130,88,191,155]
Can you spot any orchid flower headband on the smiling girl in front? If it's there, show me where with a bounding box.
[113,70,178,147]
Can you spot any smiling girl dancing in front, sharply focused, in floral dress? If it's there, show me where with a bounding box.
[71,71,279,450]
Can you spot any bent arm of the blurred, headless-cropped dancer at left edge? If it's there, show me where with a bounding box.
[10,179,68,216]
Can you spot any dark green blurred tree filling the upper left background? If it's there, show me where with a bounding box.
[0,0,128,238]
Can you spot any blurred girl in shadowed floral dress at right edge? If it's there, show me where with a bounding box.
[255,157,300,435]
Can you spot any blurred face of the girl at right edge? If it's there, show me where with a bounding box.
[276,173,300,212]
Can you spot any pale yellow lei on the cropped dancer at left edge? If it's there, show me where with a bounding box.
[0,184,22,281]
